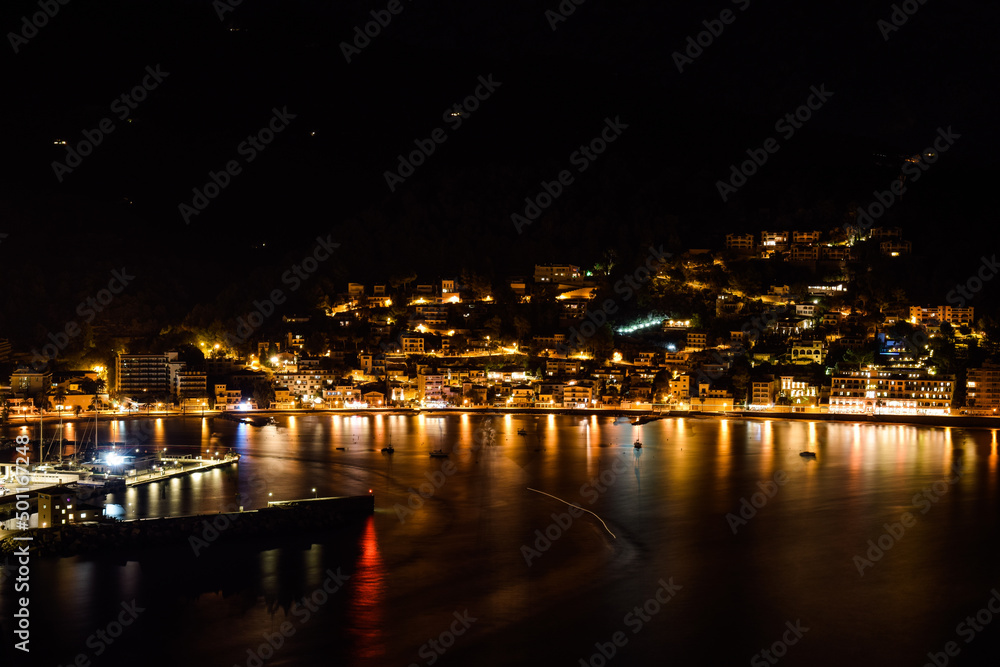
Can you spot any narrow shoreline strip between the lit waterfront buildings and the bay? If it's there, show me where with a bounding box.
[6,407,1000,429]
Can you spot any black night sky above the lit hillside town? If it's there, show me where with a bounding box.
[0,0,997,337]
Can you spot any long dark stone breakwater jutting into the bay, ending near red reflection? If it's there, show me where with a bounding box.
[0,495,375,558]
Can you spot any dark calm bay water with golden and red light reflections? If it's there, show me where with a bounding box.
[0,415,1000,666]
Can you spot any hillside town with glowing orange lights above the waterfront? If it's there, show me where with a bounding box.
[0,226,1000,419]
